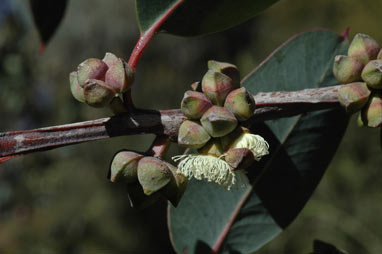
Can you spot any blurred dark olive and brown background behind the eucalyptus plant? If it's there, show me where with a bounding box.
[0,0,382,254]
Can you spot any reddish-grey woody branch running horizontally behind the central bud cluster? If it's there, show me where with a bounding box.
[0,86,340,162]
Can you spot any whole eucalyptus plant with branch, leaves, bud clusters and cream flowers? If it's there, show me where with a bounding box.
[0,0,382,253]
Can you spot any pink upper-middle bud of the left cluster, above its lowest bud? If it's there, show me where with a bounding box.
[77,58,108,87]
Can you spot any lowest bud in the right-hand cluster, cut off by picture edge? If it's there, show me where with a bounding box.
[362,93,382,128]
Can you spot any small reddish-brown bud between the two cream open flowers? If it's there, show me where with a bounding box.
[224,148,255,169]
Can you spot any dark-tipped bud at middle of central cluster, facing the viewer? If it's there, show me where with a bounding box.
[200,106,237,138]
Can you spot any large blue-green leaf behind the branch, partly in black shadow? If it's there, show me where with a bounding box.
[169,30,348,253]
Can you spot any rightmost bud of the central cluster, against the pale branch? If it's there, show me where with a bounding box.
[224,87,256,121]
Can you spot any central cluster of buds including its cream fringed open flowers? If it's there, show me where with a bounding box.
[173,61,268,189]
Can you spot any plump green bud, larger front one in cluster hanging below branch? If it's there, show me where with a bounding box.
[138,157,173,196]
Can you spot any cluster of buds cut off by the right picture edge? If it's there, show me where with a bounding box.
[333,34,382,127]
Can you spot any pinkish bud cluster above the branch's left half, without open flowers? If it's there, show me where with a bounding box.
[69,53,134,107]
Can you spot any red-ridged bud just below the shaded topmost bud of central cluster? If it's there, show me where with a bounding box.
[202,70,236,106]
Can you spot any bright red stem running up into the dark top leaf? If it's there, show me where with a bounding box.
[128,0,184,71]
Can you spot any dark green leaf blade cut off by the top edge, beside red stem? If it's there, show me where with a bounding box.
[136,0,278,36]
